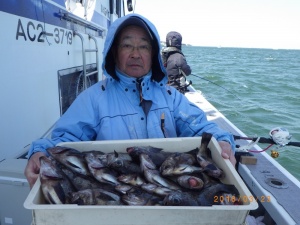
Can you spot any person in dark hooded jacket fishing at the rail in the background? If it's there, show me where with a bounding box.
[162,31,192,94]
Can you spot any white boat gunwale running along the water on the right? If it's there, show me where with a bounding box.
[185,86,300,225]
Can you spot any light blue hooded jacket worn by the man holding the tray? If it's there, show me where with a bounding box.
[28,14,235,157]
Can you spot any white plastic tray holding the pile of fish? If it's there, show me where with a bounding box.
[24,137,258,225]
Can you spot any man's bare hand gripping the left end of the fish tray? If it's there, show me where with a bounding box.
[24,152,45,189]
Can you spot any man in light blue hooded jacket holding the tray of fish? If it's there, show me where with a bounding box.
[24,14,236,187]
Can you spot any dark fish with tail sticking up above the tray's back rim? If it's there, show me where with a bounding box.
[197,133,225,179]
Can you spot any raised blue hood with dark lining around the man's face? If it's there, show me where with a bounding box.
[102,13,167,82]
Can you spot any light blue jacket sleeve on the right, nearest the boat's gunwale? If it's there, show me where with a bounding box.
[174,91,235,151]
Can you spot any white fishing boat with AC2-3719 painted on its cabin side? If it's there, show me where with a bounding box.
[0,0,300,225]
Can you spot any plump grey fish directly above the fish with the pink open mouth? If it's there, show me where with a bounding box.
[159,153,203,176]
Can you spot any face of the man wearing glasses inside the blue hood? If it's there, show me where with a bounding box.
[116,26,152,78]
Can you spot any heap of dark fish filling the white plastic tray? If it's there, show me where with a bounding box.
[40,144,240,206]
